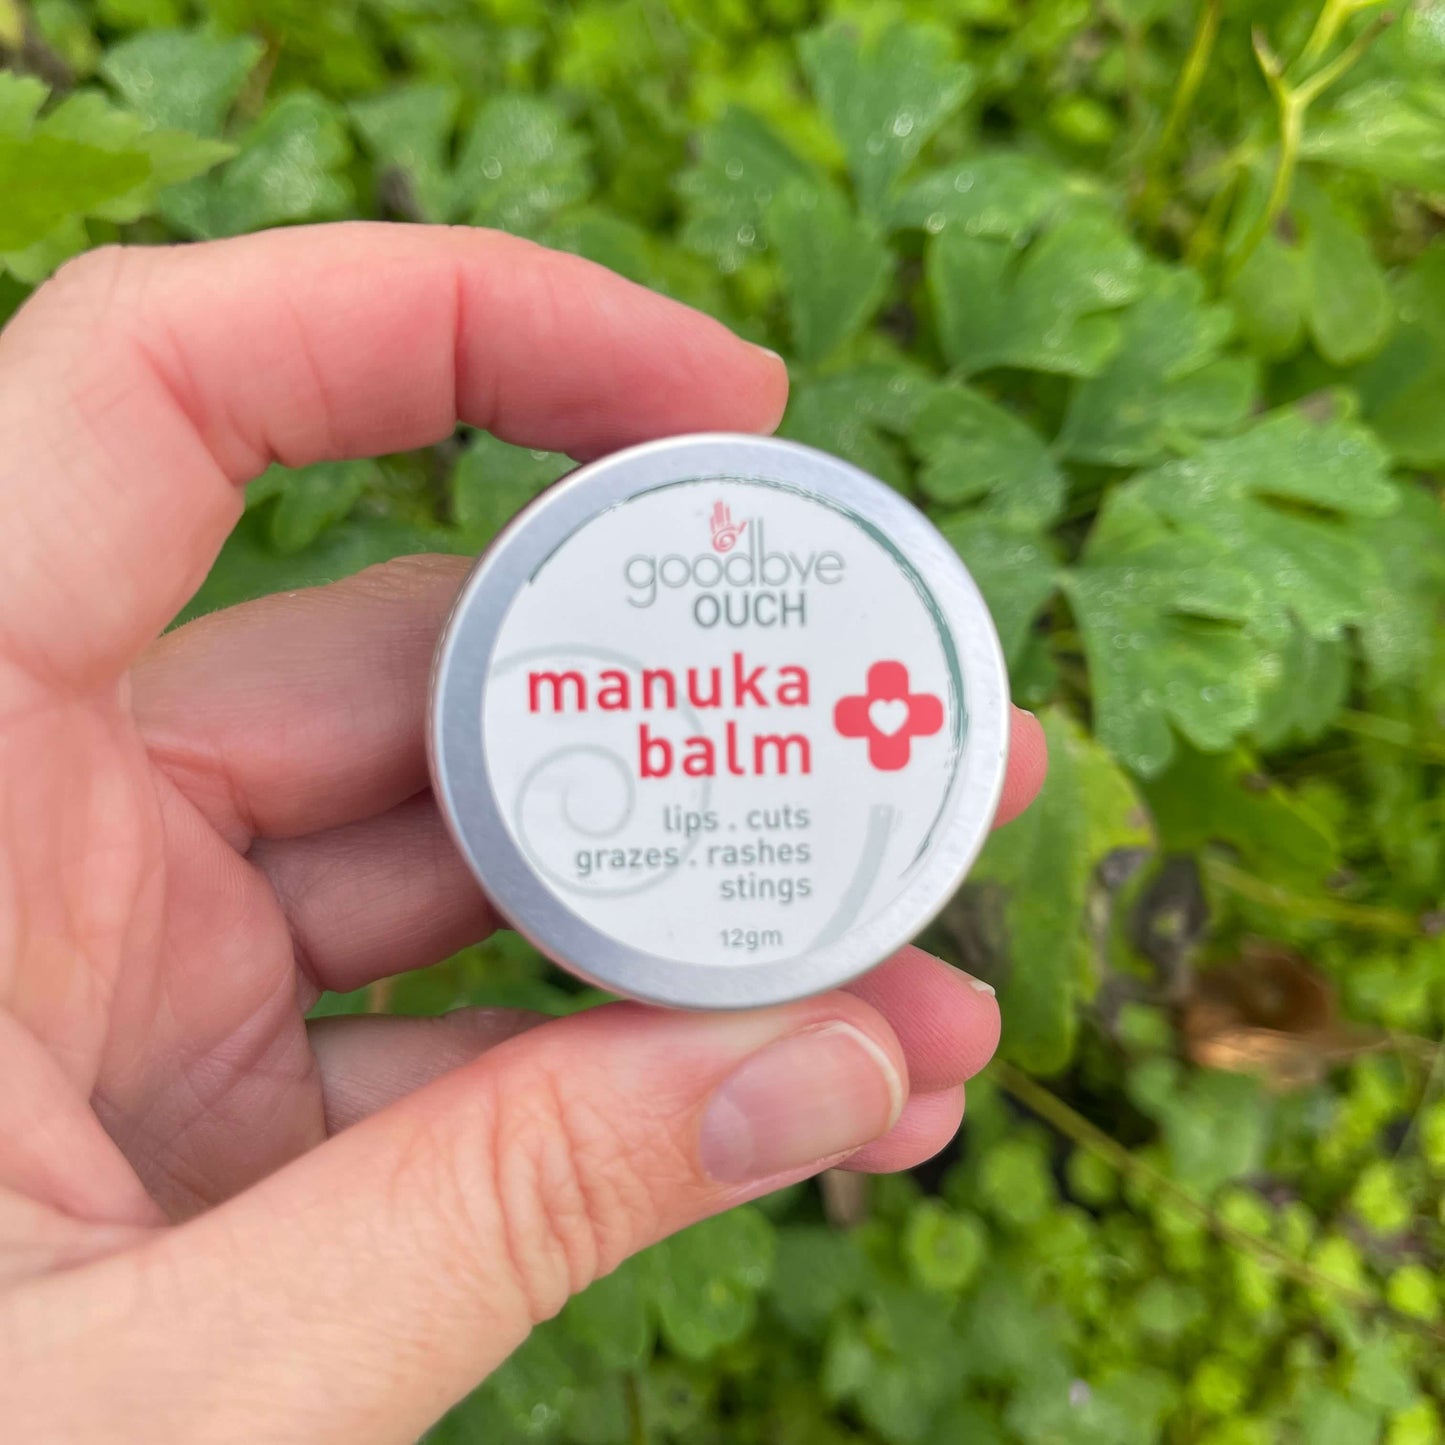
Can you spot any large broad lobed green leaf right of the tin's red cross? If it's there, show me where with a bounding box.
[1064,487,1264,776]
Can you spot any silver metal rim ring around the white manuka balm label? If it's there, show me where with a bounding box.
[426,432,1009,1009]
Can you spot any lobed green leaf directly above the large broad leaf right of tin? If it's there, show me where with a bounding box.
[1059,266,1257,467]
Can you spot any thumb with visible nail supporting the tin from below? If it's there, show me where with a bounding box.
[28,993,906,1445]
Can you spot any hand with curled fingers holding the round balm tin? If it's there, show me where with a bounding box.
[0,225,1043,1445]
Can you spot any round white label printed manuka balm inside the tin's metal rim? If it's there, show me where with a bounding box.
[480,477,967,965]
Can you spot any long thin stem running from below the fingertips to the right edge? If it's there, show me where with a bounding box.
[993,1059,1445,1340]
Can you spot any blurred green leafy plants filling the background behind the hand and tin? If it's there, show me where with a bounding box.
[0,0,1445,1445]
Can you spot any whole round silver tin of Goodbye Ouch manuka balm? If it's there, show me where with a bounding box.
[431,435,1009,1009]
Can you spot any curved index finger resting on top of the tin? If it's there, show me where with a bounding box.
[0,223,788,688]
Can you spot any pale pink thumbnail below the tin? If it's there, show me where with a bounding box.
[701,1023,903,1183]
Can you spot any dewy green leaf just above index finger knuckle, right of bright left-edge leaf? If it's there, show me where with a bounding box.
[162,91,354,237]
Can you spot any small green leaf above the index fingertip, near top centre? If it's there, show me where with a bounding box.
[678,105,818,272]
